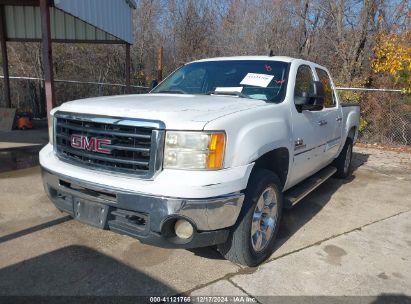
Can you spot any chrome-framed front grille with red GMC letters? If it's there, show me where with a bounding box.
[54,112,164,178]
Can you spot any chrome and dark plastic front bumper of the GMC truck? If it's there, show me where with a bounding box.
[42,168,244,248]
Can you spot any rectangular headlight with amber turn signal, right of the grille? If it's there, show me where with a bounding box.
[164,131,225,170]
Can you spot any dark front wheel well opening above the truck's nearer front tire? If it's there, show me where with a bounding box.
[254,148,290,187]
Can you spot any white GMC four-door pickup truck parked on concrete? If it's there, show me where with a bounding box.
[40,56,360,266]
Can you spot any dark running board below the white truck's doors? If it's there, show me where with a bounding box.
[284,166,337,209]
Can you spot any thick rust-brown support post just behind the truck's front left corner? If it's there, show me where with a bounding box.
[40,0,56,116]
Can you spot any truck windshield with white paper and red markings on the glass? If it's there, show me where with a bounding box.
[151,60,289,103]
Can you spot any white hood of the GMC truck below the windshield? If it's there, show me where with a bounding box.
[59,94,266,130]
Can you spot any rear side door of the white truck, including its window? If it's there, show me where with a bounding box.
[315,67,342,166]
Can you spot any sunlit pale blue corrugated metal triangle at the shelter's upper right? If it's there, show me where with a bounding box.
[54,0,134,43]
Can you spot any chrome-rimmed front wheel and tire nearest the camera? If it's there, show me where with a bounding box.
[218,169,282,266]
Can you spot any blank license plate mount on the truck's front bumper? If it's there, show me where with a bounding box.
[73,198,109,228]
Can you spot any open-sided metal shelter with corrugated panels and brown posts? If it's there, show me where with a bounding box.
[0,0,136,116]
